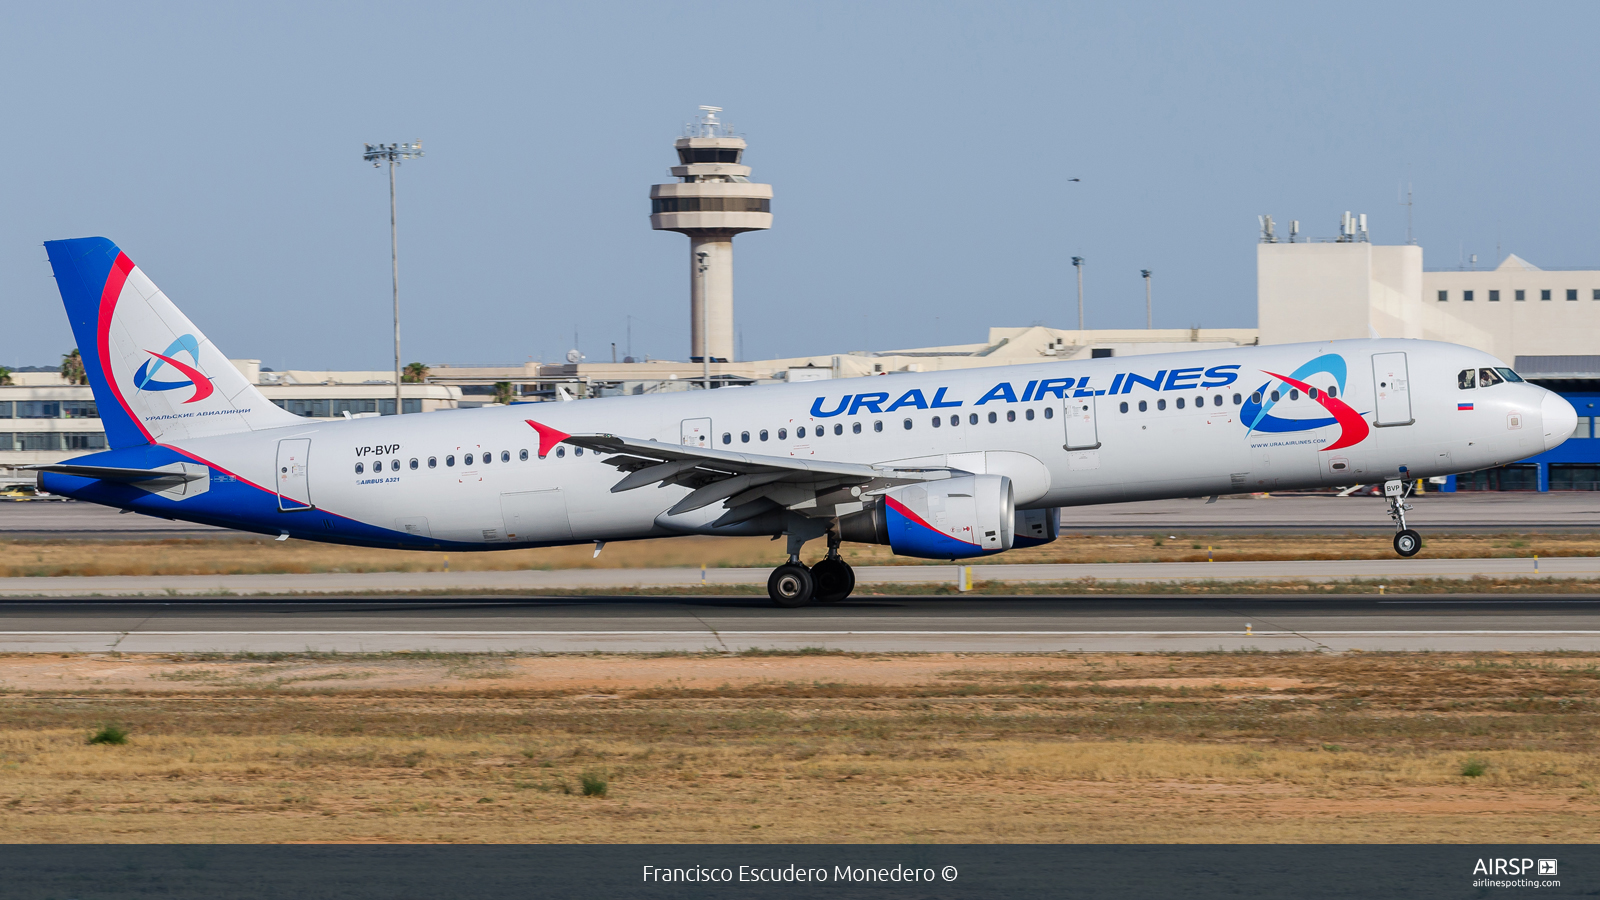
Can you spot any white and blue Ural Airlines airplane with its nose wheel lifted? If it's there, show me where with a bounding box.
[38,237,1576,607]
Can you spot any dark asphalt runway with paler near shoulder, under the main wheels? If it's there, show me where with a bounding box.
[0,596,1600,653]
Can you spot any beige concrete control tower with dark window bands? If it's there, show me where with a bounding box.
[650,106,773,362]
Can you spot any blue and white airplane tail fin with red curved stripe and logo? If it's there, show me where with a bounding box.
[45,237,304,448]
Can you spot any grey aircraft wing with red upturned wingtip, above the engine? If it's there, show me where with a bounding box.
[562,434,950,525]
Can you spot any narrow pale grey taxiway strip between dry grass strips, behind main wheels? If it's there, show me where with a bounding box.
[0,556,1600,597]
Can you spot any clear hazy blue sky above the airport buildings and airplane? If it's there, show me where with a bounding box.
[0,2,1600,368]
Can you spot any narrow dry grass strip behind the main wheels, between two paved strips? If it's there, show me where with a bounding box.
[0,533,1600,577]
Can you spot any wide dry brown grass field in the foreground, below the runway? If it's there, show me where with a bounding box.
[0,653,1600,842]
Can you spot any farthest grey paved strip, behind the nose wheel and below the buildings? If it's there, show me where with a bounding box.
[9,492,1600,540]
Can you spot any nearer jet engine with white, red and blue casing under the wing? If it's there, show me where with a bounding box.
[838,476,1016,559]
